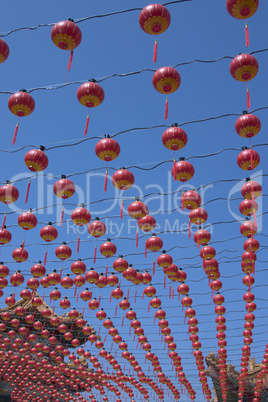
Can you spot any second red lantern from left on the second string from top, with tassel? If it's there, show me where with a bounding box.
[77,79,104,135]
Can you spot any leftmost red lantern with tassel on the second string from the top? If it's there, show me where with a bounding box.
[8,89,35,145]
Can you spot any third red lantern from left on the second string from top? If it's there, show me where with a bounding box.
[152,67,181,120]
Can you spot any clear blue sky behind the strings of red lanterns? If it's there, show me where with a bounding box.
[0,0,268,401]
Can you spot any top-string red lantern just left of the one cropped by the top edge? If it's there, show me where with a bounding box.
[139,4,171,63]
